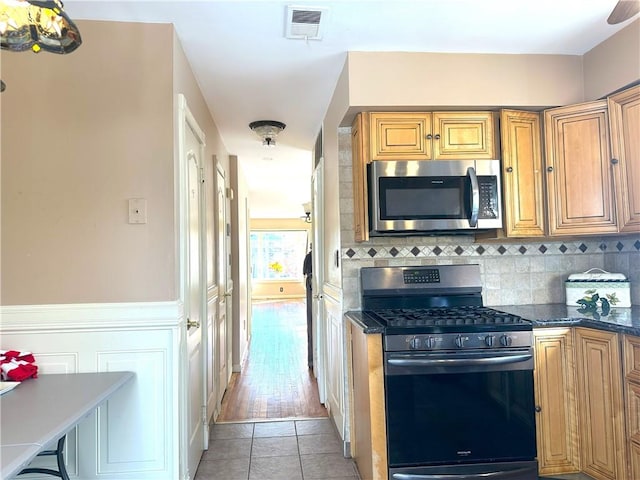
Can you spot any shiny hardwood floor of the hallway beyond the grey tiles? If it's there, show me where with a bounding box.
[216,299,328,423]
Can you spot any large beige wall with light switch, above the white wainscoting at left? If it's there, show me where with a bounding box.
[1,21,176,305]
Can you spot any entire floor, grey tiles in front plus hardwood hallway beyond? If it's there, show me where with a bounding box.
[195,299,359,480]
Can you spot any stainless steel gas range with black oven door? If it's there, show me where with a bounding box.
[361,264,538,480]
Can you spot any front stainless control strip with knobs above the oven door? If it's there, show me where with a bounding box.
[384,331,533,352]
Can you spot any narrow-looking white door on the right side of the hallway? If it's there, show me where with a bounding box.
[311,158,327,404]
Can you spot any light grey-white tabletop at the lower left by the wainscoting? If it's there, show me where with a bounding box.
[0,372,134,480]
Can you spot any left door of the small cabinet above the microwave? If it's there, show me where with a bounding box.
[370,112,432,160]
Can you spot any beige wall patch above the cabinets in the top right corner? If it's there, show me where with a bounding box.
[584,19,640,100]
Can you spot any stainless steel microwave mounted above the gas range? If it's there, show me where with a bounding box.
[368,160,502,236]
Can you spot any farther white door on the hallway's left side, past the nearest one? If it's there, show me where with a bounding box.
[216,165,232,410]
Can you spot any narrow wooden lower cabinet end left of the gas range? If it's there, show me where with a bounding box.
[347,321,388,480]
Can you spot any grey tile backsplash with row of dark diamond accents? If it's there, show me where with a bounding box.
[342,237,640,310]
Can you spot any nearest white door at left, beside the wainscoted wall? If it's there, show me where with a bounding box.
[179,96,208,479]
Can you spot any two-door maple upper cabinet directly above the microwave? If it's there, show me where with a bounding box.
[368,112,498,161]
